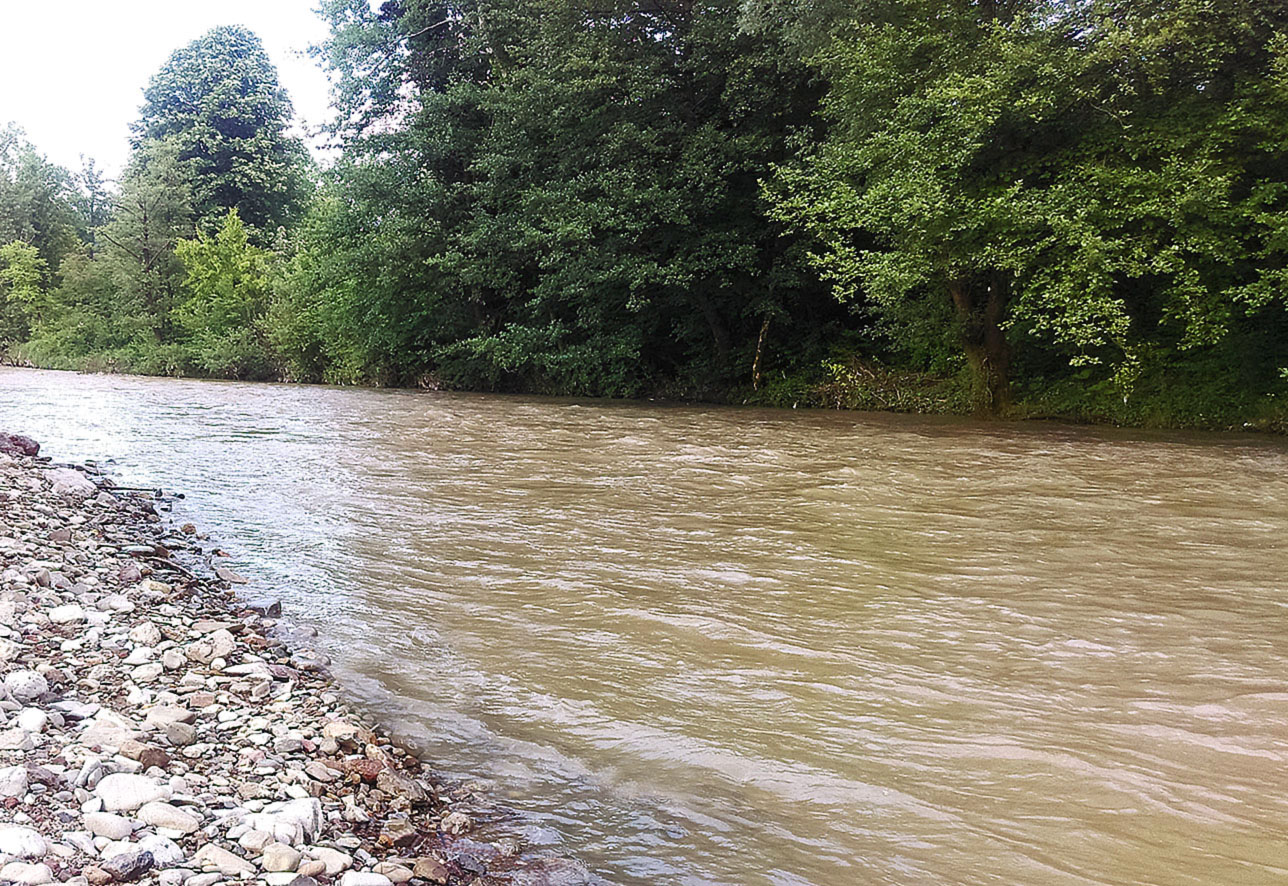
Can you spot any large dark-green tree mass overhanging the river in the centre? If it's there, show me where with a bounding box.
[296,0,844,395]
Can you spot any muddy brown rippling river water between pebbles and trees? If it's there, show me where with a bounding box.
[0,368,1288,886]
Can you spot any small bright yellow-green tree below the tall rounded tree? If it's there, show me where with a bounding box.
[175,210,269,379]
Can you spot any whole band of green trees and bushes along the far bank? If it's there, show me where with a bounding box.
[0,0,1288,430]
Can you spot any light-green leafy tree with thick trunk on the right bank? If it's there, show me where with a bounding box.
[770,0,1288,411]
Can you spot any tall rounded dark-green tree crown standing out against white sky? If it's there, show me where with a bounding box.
[134,27,307,240]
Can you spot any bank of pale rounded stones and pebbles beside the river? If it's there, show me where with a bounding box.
[0,434,595,886]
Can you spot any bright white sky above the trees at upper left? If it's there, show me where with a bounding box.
[0,0,328,175]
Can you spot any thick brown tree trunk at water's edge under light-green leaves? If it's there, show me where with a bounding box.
[948,277,1011,416]
